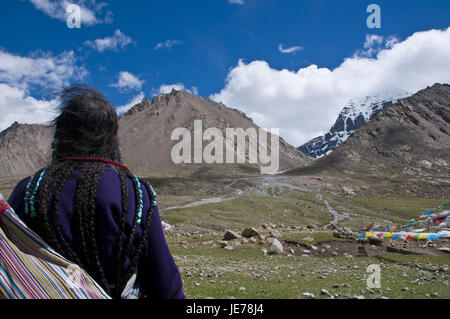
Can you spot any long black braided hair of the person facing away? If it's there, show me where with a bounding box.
[25,85,156,298]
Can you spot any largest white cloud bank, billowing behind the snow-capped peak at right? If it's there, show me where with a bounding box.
[211,28,450,146]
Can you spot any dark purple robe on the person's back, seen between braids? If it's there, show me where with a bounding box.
[8,165,185,299]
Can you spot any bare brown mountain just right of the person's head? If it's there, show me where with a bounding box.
[119,90,311,176]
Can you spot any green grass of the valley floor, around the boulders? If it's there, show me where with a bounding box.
[160,184,450,298]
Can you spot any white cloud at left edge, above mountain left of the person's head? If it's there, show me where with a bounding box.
[0,49,87,130]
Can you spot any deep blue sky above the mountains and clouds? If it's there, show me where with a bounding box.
[0,0,450,144]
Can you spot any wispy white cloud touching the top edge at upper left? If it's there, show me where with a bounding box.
[29,0,112,26]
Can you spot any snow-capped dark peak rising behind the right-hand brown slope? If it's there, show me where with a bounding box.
[298,93,411,158]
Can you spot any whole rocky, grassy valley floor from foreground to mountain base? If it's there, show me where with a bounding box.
[153,172,450,299]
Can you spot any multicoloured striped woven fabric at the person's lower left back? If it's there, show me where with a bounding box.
[0,197,111,299]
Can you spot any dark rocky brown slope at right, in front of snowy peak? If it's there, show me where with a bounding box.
[302,84,450,181]
